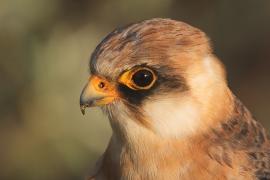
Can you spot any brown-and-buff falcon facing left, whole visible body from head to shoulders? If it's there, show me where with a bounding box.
[80,18,270,180]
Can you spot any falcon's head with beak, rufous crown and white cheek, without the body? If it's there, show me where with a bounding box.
[80,19,231,138]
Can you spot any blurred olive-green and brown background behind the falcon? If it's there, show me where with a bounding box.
[0,0,270,180]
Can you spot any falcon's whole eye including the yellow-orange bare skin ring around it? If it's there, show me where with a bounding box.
[118,67,157,90]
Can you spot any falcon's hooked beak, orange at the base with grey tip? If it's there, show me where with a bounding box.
[80,76,117,115]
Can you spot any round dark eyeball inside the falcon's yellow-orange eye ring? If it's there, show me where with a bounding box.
[132,70,154,87]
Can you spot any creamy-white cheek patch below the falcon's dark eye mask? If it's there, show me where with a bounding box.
[143,97,200,138]
